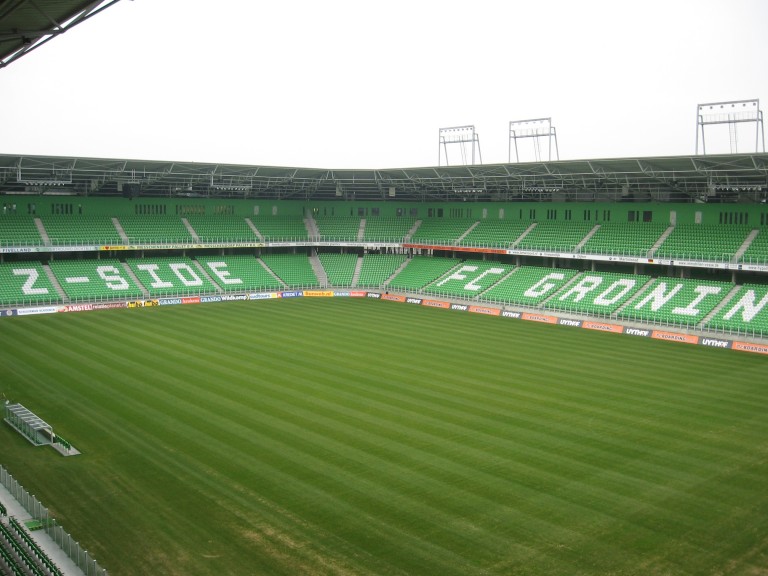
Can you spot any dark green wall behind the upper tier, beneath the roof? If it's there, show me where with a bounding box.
[0,195,768,226]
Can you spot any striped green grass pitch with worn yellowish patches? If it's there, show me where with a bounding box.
[0,298,768,576]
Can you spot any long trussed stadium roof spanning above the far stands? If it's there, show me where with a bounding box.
[0,154,768,202]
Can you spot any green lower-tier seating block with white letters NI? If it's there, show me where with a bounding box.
[618,278,733,327]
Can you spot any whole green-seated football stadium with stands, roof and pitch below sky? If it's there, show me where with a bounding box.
[0,3,768,576]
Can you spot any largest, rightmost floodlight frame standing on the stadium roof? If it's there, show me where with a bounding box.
[696,98,765,155]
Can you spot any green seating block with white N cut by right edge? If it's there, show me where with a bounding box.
[705,284,768,337]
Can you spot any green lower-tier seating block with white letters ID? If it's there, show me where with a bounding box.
[126,256,217,298]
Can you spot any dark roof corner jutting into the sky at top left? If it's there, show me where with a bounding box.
[0,0,120,68]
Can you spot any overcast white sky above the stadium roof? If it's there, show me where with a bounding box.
[0,0,768,168]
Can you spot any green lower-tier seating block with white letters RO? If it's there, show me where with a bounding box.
[545,272,651,316]
